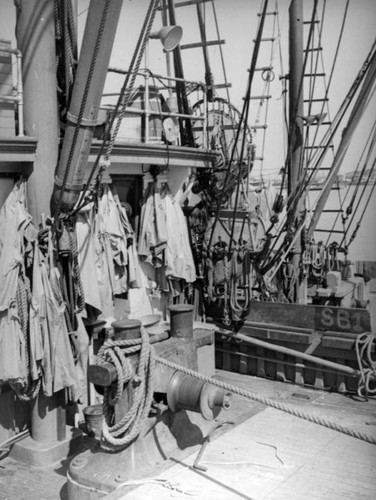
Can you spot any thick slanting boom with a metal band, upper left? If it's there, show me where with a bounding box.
[51,0,122,213]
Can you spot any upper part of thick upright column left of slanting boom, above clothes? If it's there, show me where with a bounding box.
[15,0,59,224]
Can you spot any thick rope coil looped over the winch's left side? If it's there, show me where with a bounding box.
[97,328,155,450]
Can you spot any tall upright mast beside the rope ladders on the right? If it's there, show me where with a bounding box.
[287,0,305,303]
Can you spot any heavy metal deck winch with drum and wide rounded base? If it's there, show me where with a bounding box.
[68,304,230,500]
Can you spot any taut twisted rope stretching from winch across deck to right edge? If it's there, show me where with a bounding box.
[156,357,376,444]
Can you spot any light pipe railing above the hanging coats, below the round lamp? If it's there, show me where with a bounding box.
[101,67,208,149]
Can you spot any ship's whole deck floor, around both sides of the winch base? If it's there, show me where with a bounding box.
[0,371,376,500]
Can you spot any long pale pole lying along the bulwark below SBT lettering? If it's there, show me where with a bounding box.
[216,330,360,377]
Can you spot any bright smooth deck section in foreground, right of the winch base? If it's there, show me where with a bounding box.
[114,409,376,500]
